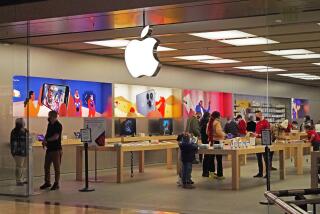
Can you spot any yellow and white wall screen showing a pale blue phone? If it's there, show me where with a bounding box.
[114,84,182,118]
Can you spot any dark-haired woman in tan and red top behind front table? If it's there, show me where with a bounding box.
[207,111,225,180]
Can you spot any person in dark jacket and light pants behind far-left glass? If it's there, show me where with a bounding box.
[10,118,28,186]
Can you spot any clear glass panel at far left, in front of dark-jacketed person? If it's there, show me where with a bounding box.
[0,23,29,196]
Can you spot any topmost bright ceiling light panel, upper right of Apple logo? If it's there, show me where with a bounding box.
[190,30,256,40]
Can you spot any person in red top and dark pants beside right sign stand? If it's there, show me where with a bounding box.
[253,111,276,178]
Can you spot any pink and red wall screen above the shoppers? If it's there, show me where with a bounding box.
[183,90,233,117]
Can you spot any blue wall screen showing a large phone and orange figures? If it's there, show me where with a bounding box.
[13,76,112,118]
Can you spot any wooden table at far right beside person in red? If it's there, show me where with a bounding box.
[274,141,312,175]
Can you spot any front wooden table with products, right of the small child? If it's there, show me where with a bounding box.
[199,145,286,190]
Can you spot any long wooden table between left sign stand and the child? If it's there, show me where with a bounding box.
[76,142,179,183]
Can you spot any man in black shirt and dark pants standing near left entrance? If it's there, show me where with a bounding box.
[40,111,62,190]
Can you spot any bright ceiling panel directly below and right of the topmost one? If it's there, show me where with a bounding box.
[219,37,279,46]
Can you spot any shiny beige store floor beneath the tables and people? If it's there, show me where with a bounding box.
[0,160,318,214]
